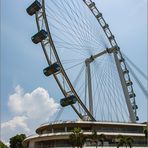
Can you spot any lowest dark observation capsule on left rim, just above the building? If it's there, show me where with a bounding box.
[60,95,77,107]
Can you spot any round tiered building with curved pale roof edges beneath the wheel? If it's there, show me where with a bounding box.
[24,121,147,148]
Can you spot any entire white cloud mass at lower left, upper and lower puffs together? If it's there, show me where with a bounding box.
[1,86,59,145]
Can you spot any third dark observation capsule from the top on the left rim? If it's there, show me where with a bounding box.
[43,63,60,76]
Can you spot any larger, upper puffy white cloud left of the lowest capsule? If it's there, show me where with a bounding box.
[8,86,59,120]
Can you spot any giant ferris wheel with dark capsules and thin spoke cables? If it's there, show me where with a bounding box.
[27,0,145,122]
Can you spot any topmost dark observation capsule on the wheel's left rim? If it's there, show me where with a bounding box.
[26,0,42,16]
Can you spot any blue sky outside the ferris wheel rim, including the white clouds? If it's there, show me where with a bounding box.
[0,0,147,146]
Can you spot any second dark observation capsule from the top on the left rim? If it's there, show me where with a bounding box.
[31,30,48,44]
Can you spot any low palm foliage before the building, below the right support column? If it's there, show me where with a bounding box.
[117,135,134,148]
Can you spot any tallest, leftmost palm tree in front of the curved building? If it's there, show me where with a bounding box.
[69,127,85,148]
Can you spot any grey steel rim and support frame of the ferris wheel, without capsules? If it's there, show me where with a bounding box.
[31,0,137,122]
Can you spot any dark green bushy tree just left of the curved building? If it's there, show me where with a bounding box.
[10,134,26,148]
